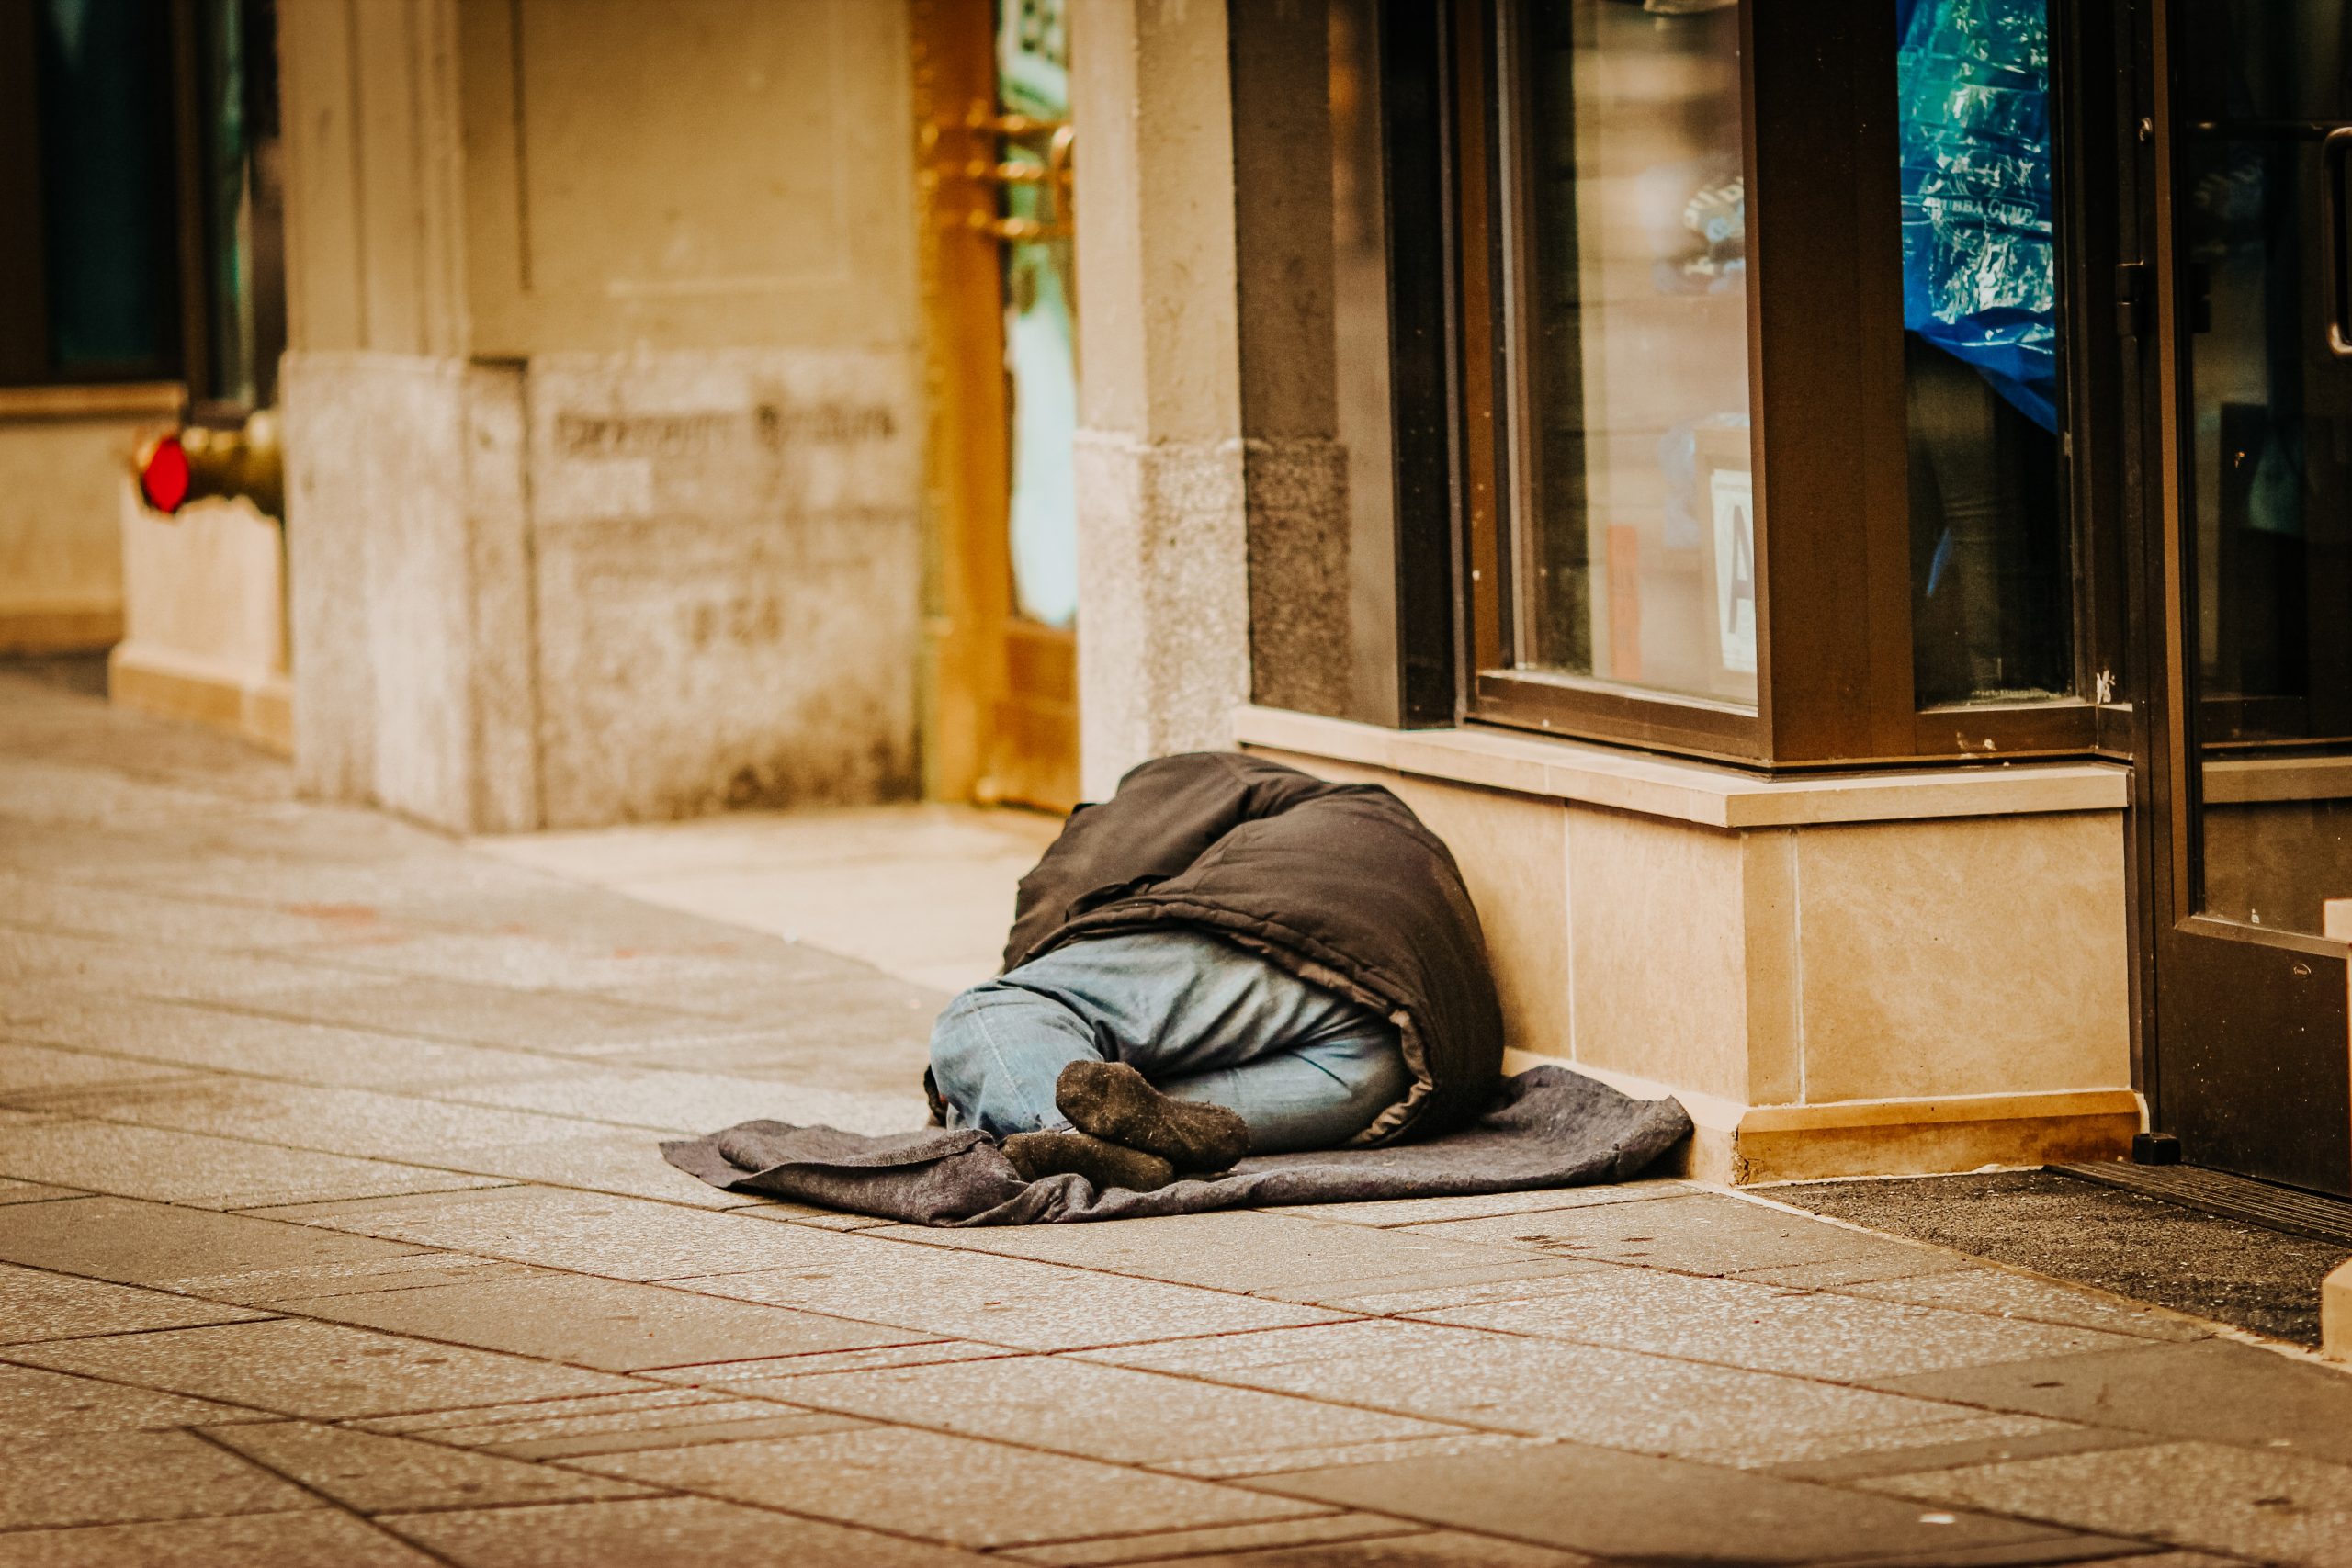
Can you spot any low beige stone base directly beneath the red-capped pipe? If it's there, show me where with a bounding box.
[106,493,294,755]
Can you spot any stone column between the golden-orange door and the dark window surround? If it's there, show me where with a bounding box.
[1070,0,1249,799]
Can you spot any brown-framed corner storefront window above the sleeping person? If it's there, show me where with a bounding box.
[1448,0,2141,766]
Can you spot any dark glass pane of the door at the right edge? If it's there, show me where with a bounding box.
[2173,0,2352,933]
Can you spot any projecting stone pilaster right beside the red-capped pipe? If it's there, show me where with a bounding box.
[280,0,501,828]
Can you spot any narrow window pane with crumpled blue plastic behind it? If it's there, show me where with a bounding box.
[1894,0,2072,707]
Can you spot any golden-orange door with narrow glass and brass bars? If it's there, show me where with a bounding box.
[912,0,1077,811]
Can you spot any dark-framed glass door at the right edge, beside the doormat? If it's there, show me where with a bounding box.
[2157,0,2352,1194]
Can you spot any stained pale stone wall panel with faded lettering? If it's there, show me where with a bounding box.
[529,353,920,825]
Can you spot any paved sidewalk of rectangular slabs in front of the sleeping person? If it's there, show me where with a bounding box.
[0,674,2352,1568]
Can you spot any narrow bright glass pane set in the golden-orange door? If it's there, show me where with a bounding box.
[997,0,1077,627]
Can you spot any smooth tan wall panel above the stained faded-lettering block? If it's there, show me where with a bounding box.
[463,0,917,355]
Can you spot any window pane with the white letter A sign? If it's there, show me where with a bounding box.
[1503,0,1757,705]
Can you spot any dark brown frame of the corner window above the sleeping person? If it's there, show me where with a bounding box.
[1440,0,2135,769]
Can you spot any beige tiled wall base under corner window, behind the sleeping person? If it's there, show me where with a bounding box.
[1235,707,2141,1182]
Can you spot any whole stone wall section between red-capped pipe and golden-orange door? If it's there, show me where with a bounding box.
[280,0,922,832]
